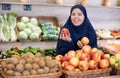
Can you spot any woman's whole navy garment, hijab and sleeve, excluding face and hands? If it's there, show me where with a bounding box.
[56,4,97,55]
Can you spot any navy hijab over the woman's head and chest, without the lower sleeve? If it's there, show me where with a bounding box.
[63,4,97,47]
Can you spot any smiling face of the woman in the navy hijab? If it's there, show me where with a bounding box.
[71,8,85,26]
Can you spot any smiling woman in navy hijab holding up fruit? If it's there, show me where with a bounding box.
[56,4,97,55]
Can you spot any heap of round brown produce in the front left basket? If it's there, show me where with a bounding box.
[1,52,60,76]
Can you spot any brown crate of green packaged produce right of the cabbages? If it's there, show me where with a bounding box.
[38,16,60,41]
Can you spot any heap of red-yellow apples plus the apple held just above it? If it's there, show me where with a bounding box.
[55,37,110,71]
